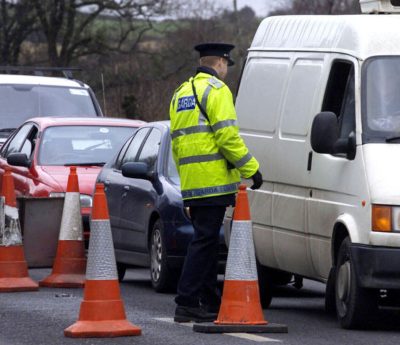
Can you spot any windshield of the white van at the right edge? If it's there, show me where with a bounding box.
[362,56,400,142]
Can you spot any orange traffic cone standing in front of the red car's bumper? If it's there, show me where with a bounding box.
[39,167,86,288]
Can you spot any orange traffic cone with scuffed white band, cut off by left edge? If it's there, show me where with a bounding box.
[0,167,39,292]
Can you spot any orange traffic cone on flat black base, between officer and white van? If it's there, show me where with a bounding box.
[193,185,287,333]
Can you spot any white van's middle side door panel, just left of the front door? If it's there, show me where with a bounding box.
[270,53,325,276]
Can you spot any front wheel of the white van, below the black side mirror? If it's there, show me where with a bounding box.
[335,237,378,329]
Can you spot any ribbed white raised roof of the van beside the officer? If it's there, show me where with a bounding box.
[249,14,400,59]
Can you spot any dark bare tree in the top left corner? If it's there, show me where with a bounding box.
[0,0,36,65]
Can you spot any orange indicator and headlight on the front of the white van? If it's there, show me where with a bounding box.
[372,205,400,232]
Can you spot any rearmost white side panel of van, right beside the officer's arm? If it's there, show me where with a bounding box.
[238,53,291,267]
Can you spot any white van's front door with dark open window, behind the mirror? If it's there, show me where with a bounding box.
[307,54,368,280]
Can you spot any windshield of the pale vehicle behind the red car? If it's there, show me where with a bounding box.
[0,84,97,135]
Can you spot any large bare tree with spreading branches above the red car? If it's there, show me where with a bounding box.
[31,0,172,66]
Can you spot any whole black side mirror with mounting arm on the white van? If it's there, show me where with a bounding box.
[311,111,357,160]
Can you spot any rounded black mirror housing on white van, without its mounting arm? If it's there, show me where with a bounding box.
[311,111,339,153]
